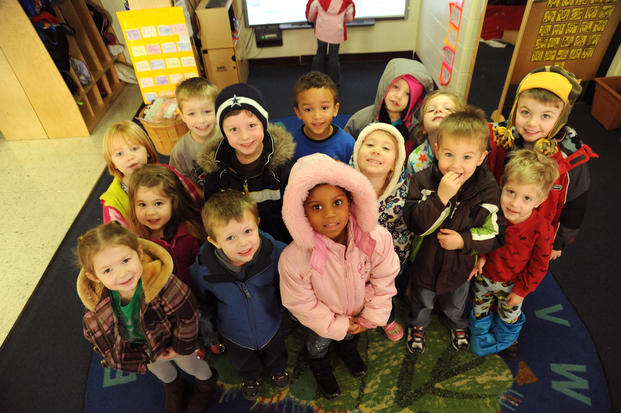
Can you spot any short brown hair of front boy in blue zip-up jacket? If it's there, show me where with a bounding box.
[201,189,259,238]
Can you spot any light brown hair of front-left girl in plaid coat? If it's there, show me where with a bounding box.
[75,221,140,274]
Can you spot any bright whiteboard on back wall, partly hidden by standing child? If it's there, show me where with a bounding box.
[244,0,407,26]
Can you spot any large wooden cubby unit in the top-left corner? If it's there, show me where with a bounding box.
[0,0,124,140]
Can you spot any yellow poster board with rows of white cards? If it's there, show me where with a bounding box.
[116,7,198,104]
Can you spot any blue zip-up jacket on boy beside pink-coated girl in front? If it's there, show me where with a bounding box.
[190,232,286,350]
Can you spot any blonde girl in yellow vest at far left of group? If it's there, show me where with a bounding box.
[99,120,157,227]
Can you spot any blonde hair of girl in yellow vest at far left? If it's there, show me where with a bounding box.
[102,120,157,180]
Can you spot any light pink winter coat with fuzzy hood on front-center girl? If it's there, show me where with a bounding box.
[278,154,399,340]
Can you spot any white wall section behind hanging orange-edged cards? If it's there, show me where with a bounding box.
[415,0,486,99]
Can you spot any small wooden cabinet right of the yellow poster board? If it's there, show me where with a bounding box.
[195,0,248,90]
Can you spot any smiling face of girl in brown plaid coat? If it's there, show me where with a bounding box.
[86,245,142,298]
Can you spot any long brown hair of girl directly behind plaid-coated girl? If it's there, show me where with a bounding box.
[127,164,205,241]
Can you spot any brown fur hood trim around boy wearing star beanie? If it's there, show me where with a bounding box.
[197,123,295,174]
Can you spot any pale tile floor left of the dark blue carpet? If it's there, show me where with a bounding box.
[0,85,142,346]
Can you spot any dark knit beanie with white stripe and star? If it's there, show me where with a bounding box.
[215,83,268,136]
